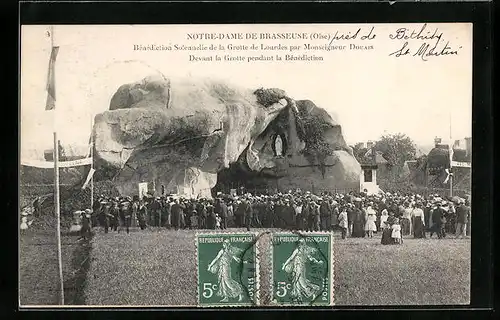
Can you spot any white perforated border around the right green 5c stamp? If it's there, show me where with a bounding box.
[267,231,335,308]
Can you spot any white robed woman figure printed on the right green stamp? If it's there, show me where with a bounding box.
[282,239,323,301]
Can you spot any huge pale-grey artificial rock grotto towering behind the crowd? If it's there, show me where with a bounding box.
[93,77,360,196]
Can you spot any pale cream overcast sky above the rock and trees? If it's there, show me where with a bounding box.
[21,24,472,158]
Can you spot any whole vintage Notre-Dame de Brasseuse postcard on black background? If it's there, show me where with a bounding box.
[19,23,474,308]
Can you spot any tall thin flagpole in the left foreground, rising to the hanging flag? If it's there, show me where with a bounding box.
[50,26,64,305]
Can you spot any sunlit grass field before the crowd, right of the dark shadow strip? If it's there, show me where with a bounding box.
[77,229,470,306]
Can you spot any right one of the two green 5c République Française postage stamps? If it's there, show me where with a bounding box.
[270,232,334,306]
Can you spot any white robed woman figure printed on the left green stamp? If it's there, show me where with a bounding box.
[208,239,243,302]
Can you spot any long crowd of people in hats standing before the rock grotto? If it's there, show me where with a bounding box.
[82,190,471,244]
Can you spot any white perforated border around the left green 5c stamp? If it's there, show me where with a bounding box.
[194,230,260,308]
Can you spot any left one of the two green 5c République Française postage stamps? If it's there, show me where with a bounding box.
[196,232,259,307]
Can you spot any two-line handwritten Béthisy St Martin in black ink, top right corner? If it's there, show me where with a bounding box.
[389,24,462,61]
